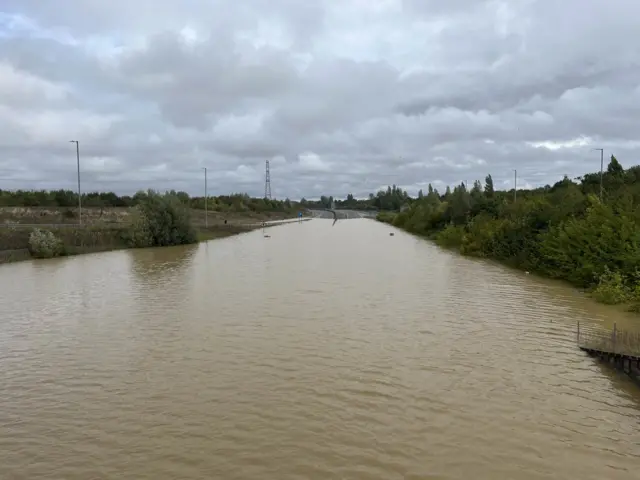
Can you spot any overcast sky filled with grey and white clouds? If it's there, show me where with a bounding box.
[0,0,640,199]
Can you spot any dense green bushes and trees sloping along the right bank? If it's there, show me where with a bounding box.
[378,156,640,311]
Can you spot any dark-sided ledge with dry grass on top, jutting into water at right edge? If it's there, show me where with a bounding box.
[577,322,640,382]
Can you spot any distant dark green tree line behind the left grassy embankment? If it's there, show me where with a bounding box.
[0,189,298,212]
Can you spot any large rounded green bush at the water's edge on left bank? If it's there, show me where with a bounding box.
[126,190,198,247]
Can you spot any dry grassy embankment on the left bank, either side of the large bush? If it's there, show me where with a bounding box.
[0,202,297,263]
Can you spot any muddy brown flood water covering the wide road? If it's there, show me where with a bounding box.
[0,220,640,480]
